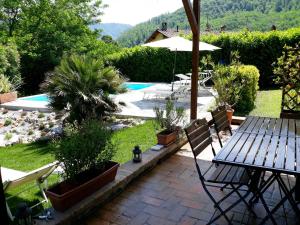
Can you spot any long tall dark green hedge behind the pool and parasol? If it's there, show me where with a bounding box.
[108,28,300,88]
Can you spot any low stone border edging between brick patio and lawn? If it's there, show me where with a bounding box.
[36,136,187,225]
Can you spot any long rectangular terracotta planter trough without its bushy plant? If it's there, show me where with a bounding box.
[46,162,119,212]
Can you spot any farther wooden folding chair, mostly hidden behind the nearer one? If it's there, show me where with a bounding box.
[211,106,232,147]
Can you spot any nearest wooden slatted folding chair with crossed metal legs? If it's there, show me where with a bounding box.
[184,119,256,224]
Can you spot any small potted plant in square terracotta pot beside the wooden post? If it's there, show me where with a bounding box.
[154,99,184,146]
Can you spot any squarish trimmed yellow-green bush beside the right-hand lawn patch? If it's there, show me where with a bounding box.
[213,64,259,113]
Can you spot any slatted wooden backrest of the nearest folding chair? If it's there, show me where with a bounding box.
[184,119,212,157]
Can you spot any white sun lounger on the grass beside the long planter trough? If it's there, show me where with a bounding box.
[2,161,59,221]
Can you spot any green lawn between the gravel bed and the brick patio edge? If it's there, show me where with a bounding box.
[0,121,156,214]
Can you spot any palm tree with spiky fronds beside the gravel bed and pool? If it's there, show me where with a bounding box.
[42,55,124,123]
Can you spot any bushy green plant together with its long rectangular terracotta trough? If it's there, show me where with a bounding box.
[46,120,119,211]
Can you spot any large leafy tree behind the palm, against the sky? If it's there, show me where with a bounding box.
[0,0,110,93]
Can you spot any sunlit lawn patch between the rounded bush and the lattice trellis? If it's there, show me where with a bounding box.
[249,90,281,117]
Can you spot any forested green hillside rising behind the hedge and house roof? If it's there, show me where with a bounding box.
[118,0,300,47]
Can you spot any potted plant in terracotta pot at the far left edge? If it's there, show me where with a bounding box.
[0,74,18,104]
